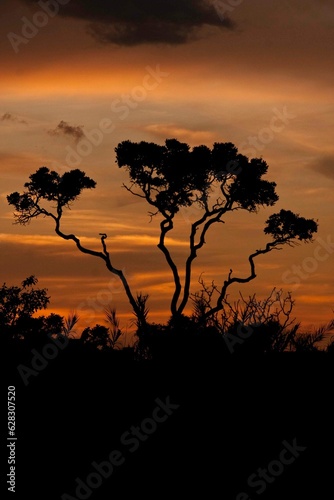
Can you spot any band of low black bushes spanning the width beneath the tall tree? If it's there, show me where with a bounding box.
[0,276,334,361]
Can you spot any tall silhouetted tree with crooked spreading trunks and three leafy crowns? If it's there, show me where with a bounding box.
[7,139,317,330]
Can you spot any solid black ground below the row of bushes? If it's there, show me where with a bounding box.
[2,346,334,500]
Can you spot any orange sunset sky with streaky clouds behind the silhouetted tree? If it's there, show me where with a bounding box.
[0,0,334,338]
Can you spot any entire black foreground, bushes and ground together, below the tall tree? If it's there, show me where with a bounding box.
[0,276,334,500]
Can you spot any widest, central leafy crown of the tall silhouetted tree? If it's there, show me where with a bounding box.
[116,139,278,217]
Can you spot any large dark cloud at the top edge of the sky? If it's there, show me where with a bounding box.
[23,0,233,46]
